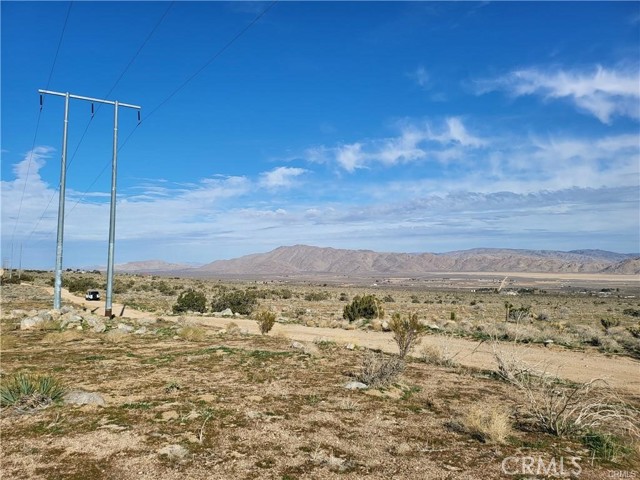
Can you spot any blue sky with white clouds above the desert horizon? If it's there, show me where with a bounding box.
[1,1,640,268]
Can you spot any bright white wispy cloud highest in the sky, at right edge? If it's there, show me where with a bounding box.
[476,65,640,124]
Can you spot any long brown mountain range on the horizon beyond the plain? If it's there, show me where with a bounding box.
[193,245,640,276]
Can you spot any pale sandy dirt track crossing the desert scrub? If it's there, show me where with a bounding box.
[53,288,640,395]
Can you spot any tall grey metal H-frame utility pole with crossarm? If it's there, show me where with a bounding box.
[38,90,141,317]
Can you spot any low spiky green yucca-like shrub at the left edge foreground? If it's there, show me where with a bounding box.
[0,373,65,412]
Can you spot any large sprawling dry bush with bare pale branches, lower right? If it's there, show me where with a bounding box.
[494,346,640,437]
